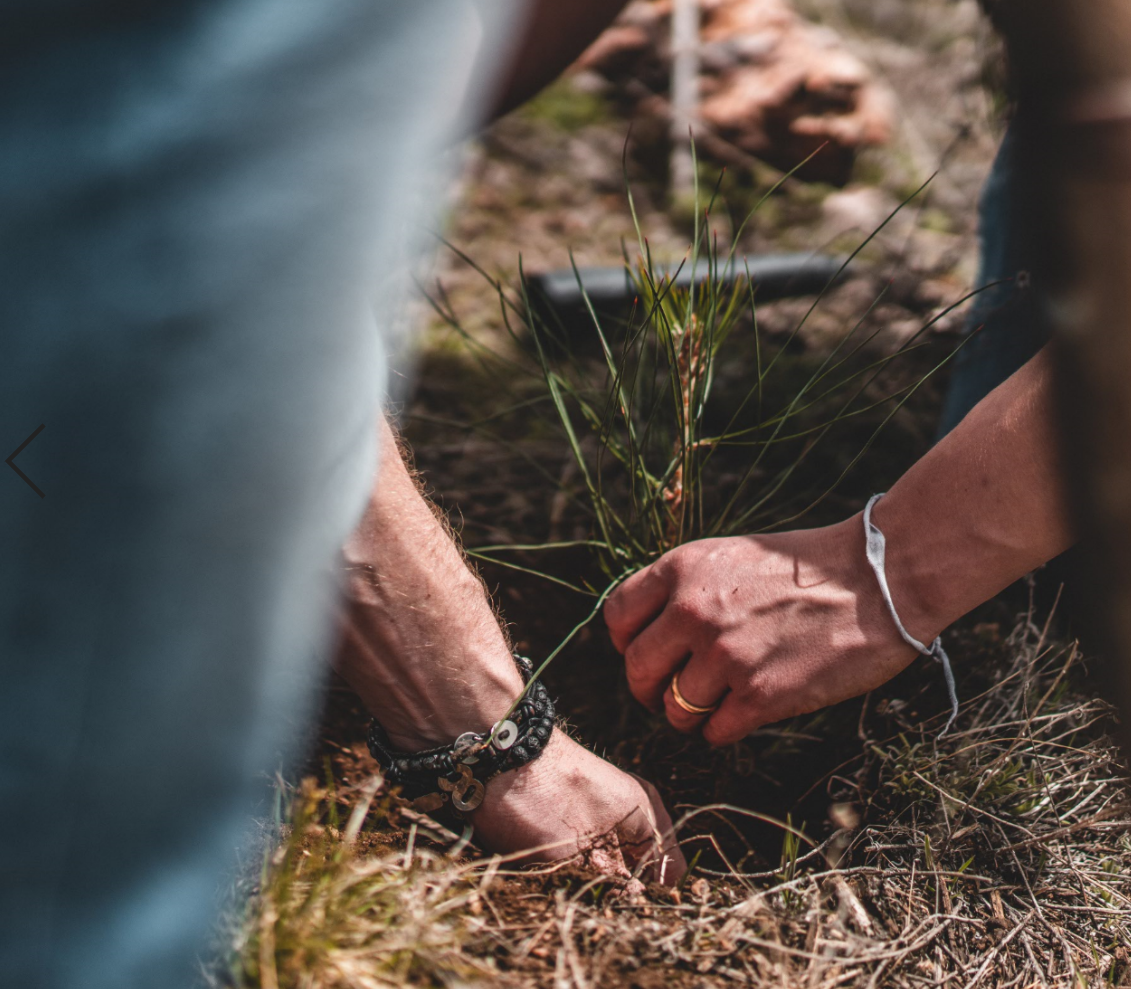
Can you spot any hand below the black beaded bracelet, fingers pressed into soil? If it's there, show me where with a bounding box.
[472,730,687,885]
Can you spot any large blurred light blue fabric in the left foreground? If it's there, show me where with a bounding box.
[0,0,517,989]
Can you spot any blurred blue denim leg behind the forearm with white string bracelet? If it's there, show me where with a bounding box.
[939,131,1047,438]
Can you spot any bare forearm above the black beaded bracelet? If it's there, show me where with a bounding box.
[336,420,523,747]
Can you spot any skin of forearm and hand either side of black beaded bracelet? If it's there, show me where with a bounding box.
[336,422,685,883]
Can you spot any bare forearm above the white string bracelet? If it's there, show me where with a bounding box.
[873,347,1073,642]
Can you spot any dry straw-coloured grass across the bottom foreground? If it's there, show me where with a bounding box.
[222,602,1131,989]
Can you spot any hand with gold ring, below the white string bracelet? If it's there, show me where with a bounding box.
[605,516,918,746]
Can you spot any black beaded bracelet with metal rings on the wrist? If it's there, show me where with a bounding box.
[369,655,554,815]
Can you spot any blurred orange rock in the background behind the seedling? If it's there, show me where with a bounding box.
[580,0,893,183]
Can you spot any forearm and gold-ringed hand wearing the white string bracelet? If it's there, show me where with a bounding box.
[605,349,1073,746]
